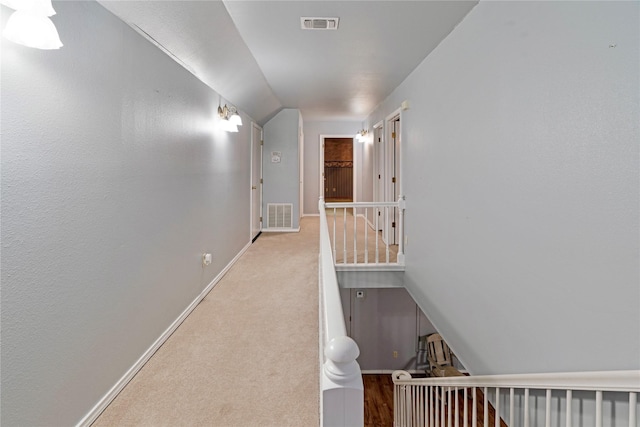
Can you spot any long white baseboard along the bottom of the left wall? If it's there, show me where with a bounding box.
[76,242,251,427]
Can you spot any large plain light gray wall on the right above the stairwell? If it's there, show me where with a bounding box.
[368,2,640,374]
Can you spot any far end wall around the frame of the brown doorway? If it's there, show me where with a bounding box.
[303,120,362,215]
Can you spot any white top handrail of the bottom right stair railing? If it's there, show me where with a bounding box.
[393,370,640,392]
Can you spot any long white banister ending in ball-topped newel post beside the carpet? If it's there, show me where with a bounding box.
[318,199,364,427]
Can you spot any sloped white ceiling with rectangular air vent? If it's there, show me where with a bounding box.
[99,0,477,124]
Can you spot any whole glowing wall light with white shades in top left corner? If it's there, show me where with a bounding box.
[2,0,62,49]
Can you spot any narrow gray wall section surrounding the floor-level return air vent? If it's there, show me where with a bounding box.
[262,108,302,228]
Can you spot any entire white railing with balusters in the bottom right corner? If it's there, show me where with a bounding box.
[393,371,640,427]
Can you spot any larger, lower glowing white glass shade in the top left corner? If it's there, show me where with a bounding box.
[2,10,62,49]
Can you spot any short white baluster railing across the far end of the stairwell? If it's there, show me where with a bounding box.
[319,196,405,267]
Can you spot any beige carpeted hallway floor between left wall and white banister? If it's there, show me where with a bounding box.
[94,217,319,427]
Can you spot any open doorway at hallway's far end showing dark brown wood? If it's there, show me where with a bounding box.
[323,137,354,202]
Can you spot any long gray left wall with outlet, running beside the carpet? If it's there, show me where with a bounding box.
[1,1,251,426]
